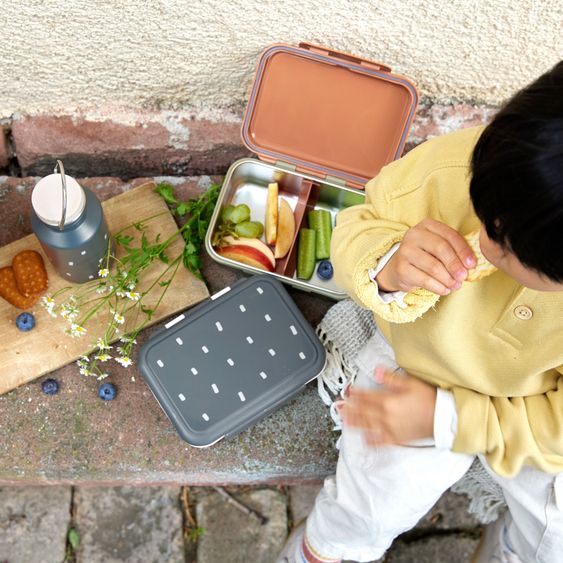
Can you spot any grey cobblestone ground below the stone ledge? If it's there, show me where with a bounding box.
[0,485,481,563]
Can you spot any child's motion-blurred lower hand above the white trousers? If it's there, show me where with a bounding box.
[338,368,436,445]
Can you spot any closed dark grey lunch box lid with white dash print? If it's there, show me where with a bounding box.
[139,276,326,447]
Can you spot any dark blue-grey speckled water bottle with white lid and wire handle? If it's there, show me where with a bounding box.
[31,160,111,283]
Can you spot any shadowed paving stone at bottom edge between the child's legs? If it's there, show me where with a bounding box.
[384,534,479,563]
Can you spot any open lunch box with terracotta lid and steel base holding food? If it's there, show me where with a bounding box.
[205,43,418,299]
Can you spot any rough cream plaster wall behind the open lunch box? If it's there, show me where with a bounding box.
[0,0,563,118]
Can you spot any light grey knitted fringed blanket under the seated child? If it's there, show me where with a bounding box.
[317,299,506,524]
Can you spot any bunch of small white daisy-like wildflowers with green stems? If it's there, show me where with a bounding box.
[42,183,220,380]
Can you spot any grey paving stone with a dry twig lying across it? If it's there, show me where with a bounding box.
[197,489,287,563]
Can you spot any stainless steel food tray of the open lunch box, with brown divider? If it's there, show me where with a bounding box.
[205,158,364,299]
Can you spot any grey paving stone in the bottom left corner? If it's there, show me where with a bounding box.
[0,487,71,563]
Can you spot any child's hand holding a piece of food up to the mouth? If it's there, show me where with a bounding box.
[376,219,475,295]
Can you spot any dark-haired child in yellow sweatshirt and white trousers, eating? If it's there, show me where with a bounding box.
[280,62,563,563]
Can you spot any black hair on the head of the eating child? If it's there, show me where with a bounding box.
[470,61,563,282]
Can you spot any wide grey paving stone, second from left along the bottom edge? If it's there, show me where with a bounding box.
[74,487,184,563]
